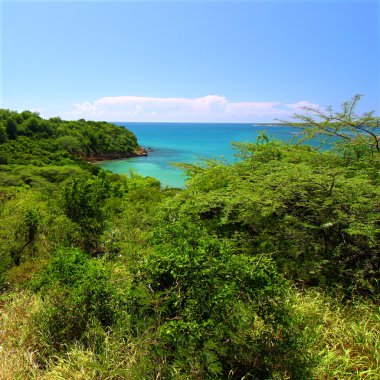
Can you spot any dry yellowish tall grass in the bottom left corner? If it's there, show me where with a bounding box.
[0,291,152,380]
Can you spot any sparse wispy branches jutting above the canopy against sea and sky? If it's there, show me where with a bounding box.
[286,95,380,158]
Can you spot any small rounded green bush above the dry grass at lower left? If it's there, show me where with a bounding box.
[33,249,119,348]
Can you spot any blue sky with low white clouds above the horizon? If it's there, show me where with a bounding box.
[1,0,380,122]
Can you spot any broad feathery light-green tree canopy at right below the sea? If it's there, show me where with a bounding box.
[175,142,380,295]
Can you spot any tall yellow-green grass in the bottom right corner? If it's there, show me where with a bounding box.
[296,291,380,380]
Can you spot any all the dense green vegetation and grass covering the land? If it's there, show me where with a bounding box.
[0,101,380,379]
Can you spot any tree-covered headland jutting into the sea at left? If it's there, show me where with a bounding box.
[0,109,139,166]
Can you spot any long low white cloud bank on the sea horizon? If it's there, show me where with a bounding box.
[60,95,319,122]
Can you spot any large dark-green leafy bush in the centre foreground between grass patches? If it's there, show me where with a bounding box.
[126,218,309,379]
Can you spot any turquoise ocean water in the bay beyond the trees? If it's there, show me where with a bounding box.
[100,122,308,187]
